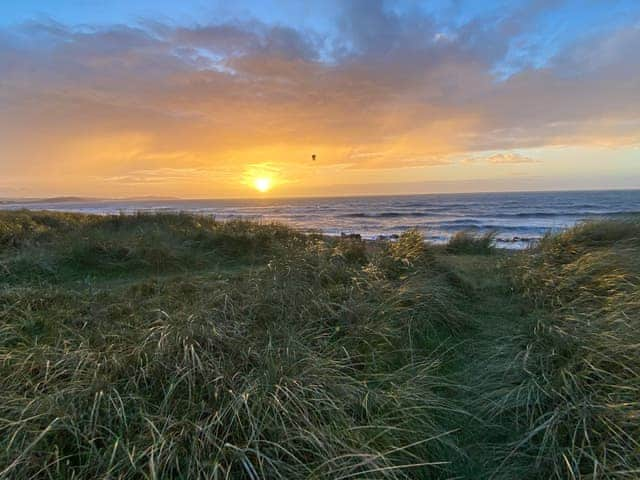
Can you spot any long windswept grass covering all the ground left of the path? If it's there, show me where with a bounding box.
[0,212,465,479]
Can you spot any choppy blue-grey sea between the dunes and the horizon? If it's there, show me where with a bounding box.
[0,190,640,249]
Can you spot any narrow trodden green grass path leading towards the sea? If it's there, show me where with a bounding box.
[444,255,527,479]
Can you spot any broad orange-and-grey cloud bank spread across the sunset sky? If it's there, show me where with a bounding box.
[0,1,640,193]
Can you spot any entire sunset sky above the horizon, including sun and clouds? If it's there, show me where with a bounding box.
[0,0,640,198]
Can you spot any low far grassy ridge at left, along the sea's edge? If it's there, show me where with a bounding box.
[0,212,303,283]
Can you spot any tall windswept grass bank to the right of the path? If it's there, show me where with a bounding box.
[502,220,640,479]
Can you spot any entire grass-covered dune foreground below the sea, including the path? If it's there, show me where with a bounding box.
[0,212,640,480]
